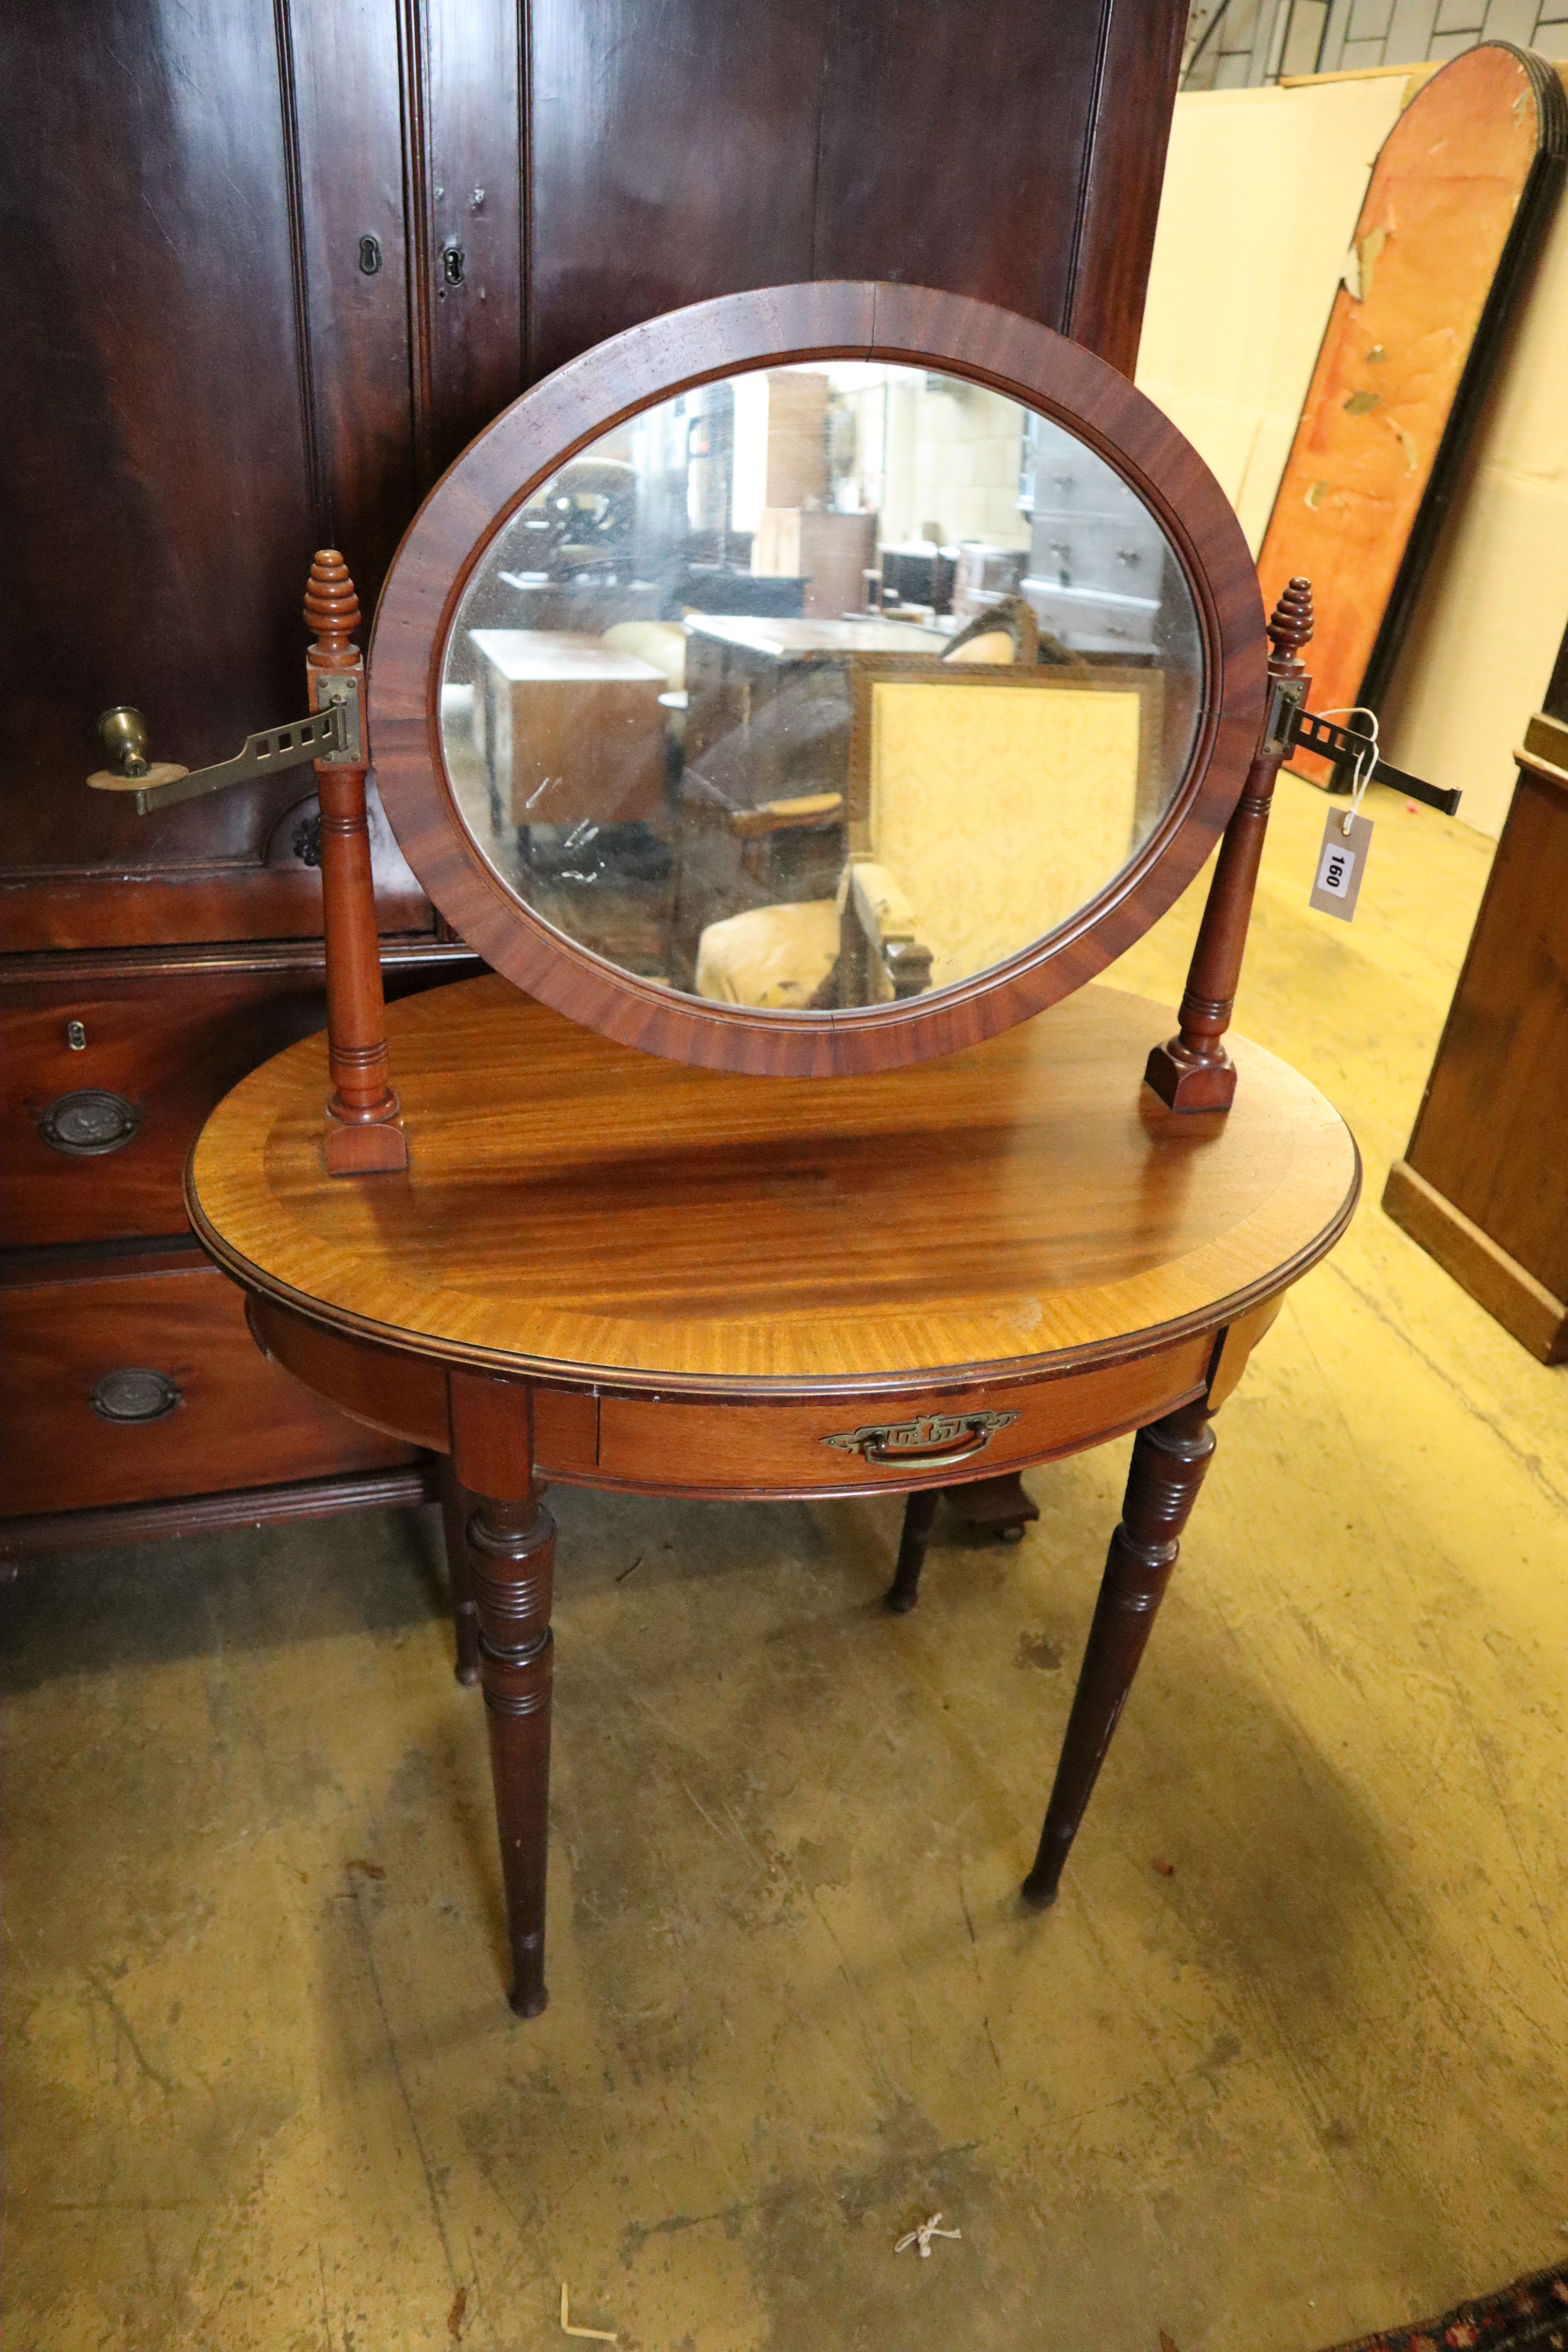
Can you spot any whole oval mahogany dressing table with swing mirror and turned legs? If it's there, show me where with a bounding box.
[169,285,1359,2016]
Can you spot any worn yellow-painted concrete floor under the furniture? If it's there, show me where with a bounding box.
[5,781,1568,2352]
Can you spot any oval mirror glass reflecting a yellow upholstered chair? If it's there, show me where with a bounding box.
[442,360,1203,1011]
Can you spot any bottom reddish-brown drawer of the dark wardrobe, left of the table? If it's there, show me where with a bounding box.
[0,1261,416,1515]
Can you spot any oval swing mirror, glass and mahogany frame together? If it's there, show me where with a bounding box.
[369,285,1262,1073]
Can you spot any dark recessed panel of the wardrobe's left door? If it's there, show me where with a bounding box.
[0,0,315,870]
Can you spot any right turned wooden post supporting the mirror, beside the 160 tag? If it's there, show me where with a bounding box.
[1143,579,1312,1110]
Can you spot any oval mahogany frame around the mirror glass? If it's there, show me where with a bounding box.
[369,280,1267,1077]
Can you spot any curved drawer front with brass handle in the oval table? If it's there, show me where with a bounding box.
[599,1334,1213,1496]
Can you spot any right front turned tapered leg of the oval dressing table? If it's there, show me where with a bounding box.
[1023,1402,1213,1910]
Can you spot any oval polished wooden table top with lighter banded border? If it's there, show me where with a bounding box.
[186,976,1359,1395]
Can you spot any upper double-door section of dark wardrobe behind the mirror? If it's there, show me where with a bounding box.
[0,0,1185,946]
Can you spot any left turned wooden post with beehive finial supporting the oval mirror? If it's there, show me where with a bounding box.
[306,548,409,1176]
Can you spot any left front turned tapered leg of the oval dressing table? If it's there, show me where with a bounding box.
[468,1496,555,2018]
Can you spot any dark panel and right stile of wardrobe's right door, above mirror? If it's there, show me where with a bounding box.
[526,0,1185,381]
